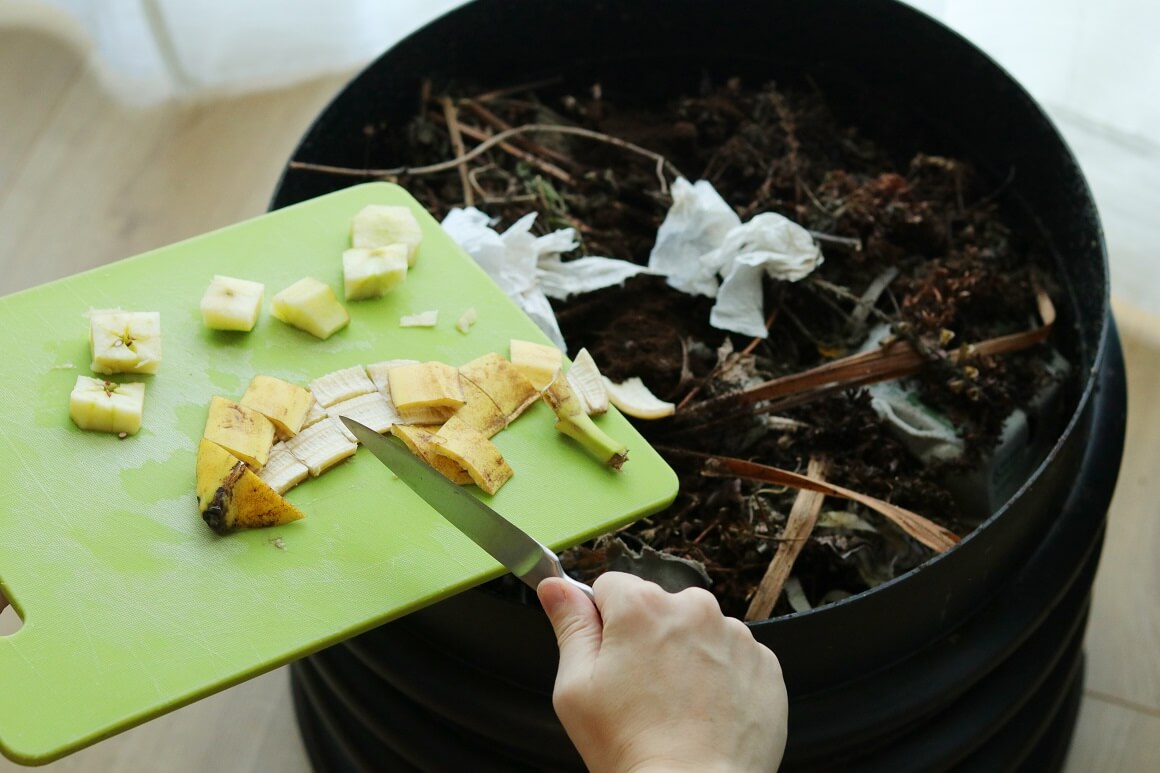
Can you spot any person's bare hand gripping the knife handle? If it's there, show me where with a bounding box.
[537,572,789,772]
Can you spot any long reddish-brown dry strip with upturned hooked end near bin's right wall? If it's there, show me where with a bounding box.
[684,290,1056,416]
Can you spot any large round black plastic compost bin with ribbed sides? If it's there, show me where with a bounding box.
[273,0,1126,771]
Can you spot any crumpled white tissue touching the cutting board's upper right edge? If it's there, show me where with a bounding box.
[443,207,653,351]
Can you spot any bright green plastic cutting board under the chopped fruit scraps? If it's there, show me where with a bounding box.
[0,183,677,763]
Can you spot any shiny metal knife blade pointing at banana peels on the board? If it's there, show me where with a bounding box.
[341,417,594,599]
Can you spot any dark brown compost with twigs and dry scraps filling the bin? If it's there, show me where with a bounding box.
[322,80,1052,617]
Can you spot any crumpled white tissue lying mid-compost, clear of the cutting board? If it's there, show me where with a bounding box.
[648,179,822,338]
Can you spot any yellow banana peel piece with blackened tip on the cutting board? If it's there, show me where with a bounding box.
[197,438,303,534]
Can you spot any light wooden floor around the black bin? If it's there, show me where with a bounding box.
[0,21,1160,773]
